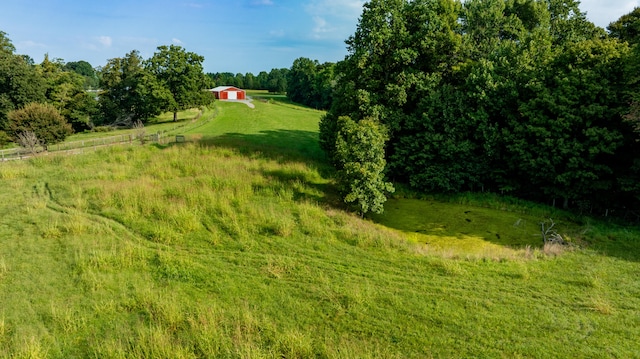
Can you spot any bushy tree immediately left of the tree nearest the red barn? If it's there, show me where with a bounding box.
[99,50,174,125]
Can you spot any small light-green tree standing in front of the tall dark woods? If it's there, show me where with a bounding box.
[336,117,394,215]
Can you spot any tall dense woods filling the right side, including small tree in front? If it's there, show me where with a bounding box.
[318,0,640,213]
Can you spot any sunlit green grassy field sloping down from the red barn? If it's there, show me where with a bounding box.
[0,101,640,358]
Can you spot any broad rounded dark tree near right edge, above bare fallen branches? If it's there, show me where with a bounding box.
[505,39,626,205]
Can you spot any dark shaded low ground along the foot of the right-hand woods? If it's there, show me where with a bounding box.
[370,199,640,262]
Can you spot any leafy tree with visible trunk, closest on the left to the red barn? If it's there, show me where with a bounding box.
[145,45,212,121]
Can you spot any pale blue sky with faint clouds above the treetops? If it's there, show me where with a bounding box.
[0,0,640,75]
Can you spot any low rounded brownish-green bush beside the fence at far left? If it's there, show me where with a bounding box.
[7,103,73,149]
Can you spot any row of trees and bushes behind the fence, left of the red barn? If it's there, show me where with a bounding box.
[0,31,213,149]
